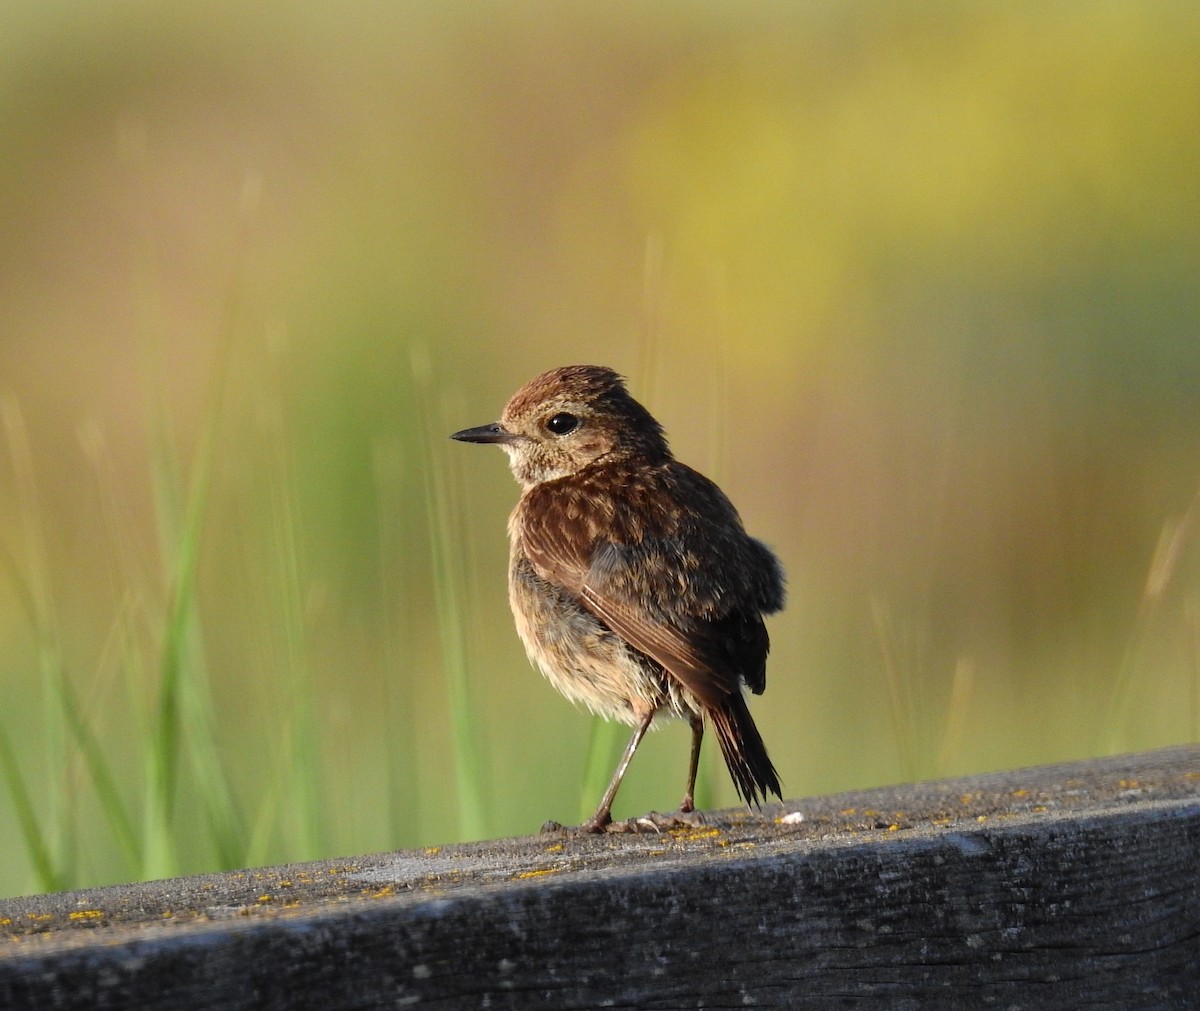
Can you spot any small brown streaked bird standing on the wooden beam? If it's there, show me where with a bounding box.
[451,365,784,832]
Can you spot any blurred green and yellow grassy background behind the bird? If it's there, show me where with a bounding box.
[0,0,1200,893]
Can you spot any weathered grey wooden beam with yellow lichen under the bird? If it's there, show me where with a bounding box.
[0,746,1200,1009]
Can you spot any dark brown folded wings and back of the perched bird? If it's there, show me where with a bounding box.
[522,463,782,707]
